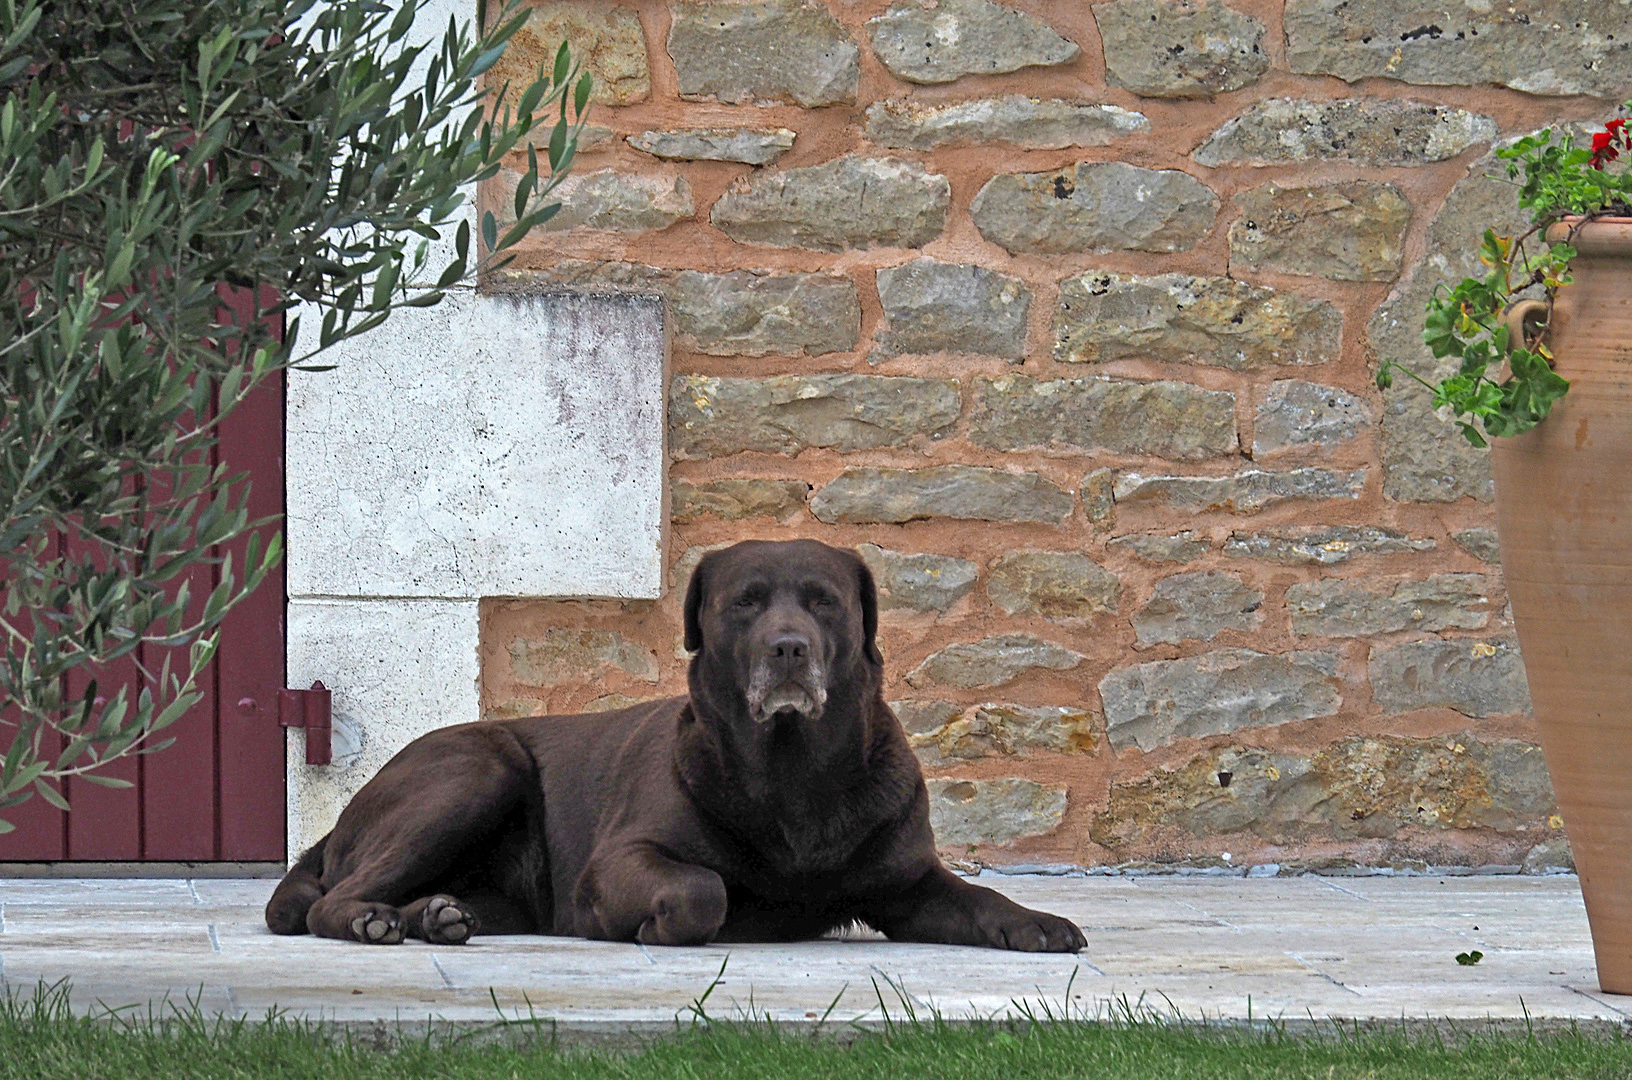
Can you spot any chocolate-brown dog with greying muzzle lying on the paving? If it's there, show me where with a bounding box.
[266,540,1084,953]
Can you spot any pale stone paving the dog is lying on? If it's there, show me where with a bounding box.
[0,874,1632,1031]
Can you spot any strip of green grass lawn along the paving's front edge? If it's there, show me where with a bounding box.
[0,987,1632,1080]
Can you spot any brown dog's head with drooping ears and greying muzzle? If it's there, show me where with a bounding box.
[685,540,885,724]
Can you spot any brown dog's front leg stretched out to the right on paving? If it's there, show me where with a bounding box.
[863,866,1087,953]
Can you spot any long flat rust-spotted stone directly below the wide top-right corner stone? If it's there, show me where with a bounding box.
[1191,98,1497,166]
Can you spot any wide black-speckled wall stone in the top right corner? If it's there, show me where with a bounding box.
[1286,0,1632,101]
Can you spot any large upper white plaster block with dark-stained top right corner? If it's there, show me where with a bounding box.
[287,292,667,599]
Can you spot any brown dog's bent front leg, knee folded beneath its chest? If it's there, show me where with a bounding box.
[574,843,726,945]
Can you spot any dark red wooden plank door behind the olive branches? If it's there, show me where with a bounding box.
[0,295,286,861]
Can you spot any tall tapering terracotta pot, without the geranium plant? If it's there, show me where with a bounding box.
[1492,219,1632,994]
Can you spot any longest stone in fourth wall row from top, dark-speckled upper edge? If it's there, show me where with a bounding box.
[1054,271,1343,370]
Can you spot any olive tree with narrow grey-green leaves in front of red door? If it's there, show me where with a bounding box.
[0,0,589,832]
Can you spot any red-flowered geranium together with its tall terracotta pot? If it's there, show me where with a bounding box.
[1377,110,1632,994]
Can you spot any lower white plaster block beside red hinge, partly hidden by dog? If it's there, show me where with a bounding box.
[287,600,480,860]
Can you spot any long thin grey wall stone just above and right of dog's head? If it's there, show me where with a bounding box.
[811,465,1071,525]
